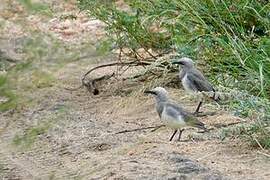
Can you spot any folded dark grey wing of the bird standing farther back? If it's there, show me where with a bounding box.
[187,69,215,91]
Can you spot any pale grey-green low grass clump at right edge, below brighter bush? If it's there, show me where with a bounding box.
[221,87,270,149]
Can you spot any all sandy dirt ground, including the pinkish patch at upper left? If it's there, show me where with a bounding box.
[0,1,270,180]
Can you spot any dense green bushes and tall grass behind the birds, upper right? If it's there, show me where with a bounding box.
[79,0,270,148]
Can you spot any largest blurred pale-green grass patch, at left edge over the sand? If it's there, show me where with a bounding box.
[0,29,93,112]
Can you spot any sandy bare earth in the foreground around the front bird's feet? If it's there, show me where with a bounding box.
[0,61,269,179]
